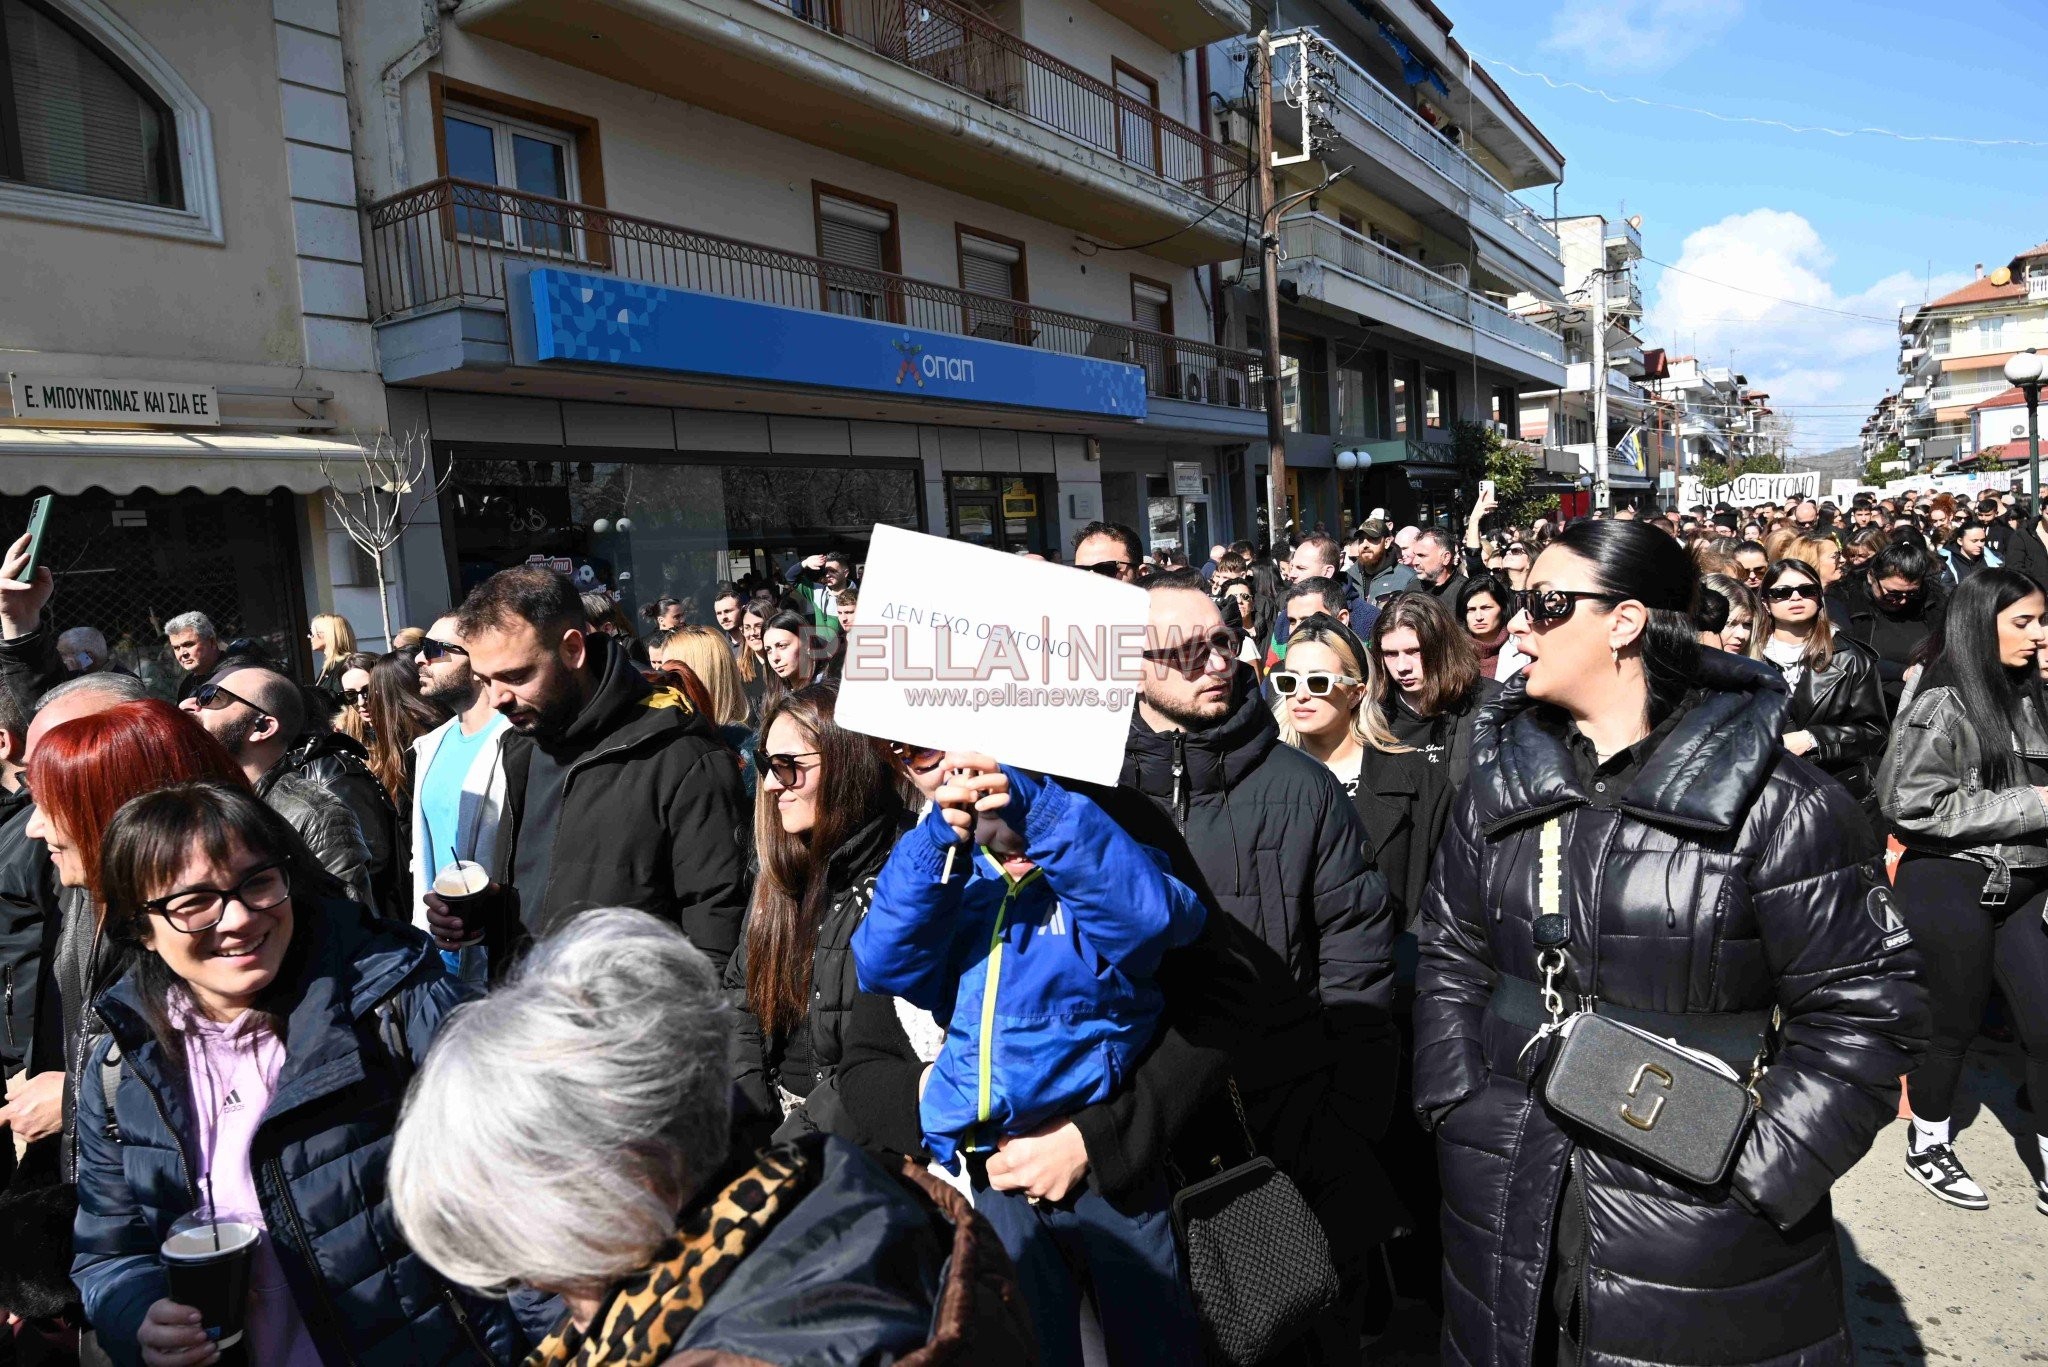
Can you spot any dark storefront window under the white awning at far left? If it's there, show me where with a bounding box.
[0,490,303,697]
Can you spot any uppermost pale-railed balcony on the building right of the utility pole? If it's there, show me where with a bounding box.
[1237,29,1565,293]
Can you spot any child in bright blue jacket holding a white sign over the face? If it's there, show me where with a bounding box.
[854,764,1206,1363]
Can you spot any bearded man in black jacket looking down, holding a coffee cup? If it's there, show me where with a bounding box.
[452,566,748,971]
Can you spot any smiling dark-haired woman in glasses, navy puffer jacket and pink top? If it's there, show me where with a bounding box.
[74,783,524,1367]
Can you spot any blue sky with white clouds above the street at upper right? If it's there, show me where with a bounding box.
[1444,0,2048,451]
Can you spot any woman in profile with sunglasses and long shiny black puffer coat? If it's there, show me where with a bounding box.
[1415,521,1925,1367]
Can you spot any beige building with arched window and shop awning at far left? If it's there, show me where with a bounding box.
[0,0,395,691]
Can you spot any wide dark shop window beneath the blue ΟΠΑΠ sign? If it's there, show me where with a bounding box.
[446,443,924,621]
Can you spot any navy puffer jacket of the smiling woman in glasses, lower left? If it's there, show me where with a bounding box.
[72,900,526,1367]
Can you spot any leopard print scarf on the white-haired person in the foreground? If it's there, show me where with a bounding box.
[526,1144,821,1367]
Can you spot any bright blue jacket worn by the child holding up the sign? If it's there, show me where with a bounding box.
[854,767,1206,1164]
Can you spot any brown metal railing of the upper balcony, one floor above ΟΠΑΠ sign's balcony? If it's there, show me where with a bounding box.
[762,0,1249,203]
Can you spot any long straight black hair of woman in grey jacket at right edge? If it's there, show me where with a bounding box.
[1921,568,2042,789]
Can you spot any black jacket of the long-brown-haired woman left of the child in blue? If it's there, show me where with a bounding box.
[725,814,903,1137]
